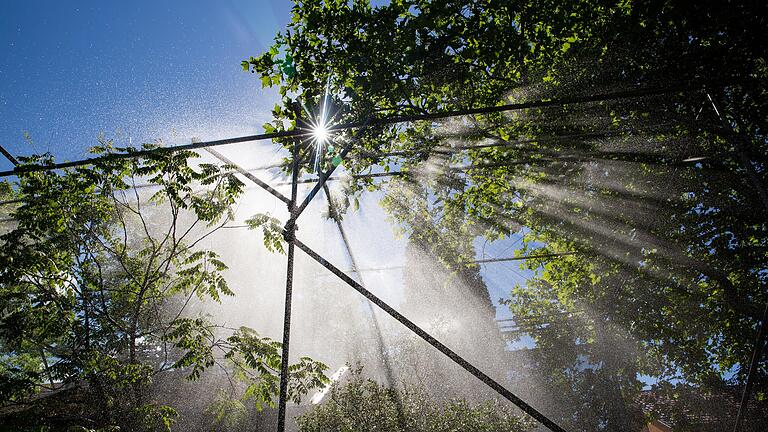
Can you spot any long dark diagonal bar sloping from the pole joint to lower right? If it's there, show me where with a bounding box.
[294,239,565,432]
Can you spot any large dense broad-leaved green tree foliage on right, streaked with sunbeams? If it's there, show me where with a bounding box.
[249,0,768,430]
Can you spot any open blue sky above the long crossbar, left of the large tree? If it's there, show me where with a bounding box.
[0,0,292,169]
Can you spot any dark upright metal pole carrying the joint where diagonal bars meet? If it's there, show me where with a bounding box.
[277,141,299,432]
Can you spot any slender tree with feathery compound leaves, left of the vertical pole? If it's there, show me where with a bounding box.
[0,140,326,430]
